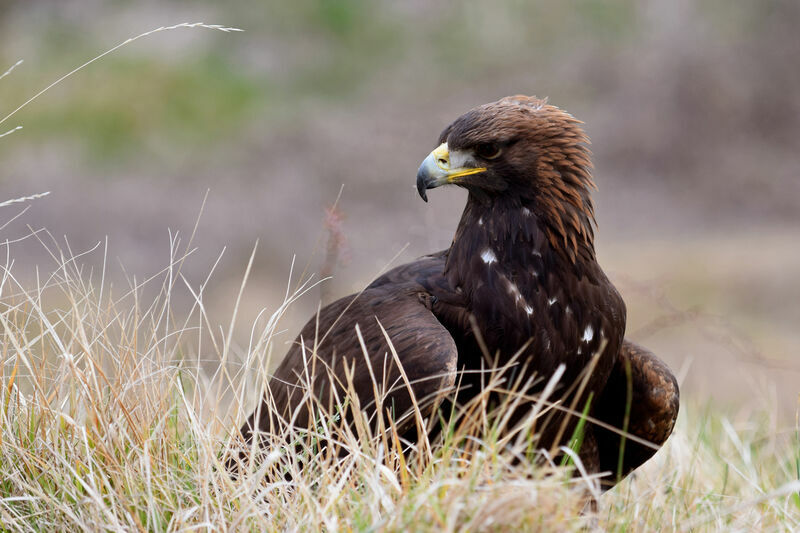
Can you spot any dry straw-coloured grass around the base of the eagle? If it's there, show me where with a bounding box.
[0,227,800,531]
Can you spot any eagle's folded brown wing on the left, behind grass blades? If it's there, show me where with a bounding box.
[241,256,458,442]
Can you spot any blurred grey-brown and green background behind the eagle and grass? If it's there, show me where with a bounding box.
[0,0,800,420]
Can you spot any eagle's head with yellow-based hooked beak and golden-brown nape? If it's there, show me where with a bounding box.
[417,95,595,260]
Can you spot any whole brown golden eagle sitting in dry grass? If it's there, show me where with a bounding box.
[233,96,678,486]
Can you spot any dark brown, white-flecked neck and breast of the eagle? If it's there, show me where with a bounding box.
[444,169,625,371]
